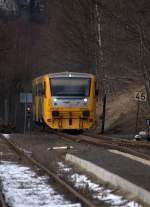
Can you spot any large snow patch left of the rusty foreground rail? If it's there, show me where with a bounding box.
[0,161,81,207]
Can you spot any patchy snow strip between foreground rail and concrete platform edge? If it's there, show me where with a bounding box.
[58,162,142,207]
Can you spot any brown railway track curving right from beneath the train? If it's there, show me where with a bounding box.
[55,132,150,160]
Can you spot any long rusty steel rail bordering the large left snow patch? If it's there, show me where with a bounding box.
[3,137,96,207]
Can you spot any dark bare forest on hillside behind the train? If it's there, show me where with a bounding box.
[0,0,150,129]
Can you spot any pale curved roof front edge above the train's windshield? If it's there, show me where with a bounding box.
[48,72,93,78]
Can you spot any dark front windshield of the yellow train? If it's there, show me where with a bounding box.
[50,77,91,97]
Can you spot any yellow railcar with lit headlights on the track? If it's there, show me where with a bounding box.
[32,72,96,130]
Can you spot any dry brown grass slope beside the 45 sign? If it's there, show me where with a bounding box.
[97,82,150,134]
